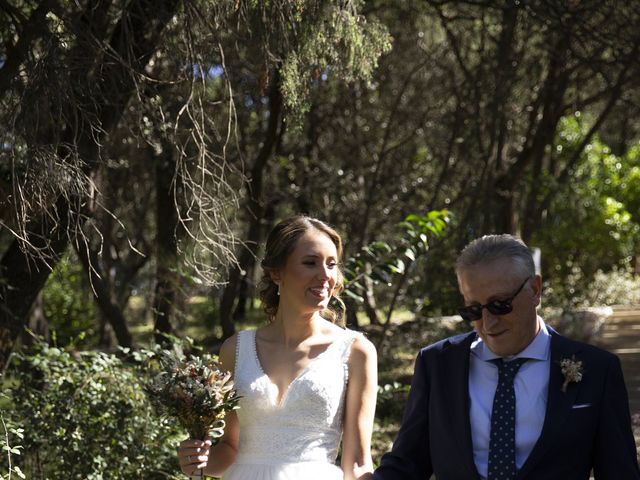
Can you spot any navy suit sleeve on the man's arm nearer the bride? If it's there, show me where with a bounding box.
[373,350,433,480]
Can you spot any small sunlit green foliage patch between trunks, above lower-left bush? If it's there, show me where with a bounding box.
[42,256,97,346]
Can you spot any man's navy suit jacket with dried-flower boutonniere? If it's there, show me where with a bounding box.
[373,329,640,480]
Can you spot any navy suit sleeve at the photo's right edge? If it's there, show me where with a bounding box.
[593,356,640,480]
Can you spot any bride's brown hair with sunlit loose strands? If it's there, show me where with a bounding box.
[259,215,345,325]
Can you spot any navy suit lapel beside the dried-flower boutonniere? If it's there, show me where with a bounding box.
[516,331,580,479]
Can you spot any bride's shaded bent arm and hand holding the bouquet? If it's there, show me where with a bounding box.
[178,335,240,477]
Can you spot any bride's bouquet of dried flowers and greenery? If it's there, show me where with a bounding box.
[146,345,240,476]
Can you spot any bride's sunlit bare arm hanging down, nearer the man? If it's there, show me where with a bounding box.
[341,336,378,480]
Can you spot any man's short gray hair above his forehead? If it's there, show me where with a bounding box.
[456,233,536,276]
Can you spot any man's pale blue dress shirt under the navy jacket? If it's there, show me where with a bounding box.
[469,317,551,480]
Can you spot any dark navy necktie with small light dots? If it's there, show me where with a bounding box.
[487,358,527,480]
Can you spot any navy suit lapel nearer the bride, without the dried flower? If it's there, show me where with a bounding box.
[439,333,480,479]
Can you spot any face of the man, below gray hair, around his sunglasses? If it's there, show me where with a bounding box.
[458,259,541,357]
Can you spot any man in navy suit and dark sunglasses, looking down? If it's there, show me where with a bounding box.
[373,235,640,480]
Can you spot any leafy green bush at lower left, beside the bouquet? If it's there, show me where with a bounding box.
[5,342,179,479]
